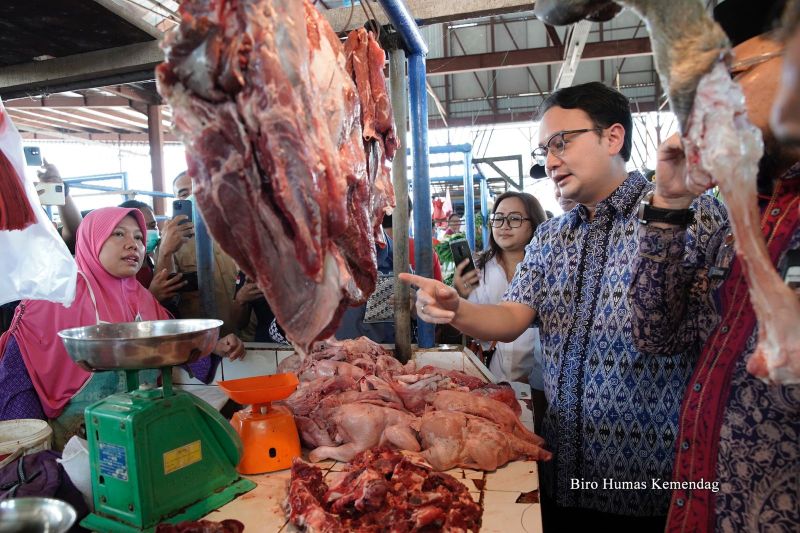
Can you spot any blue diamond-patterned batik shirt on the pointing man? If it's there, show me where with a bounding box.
[504,172,724,516]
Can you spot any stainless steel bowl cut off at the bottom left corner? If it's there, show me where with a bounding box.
[0,498,77,533]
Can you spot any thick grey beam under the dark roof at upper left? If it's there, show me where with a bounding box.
[0,41,164,98]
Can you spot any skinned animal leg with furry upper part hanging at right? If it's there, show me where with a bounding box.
[536,0,800,384]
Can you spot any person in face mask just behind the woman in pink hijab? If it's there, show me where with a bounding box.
[119,200,186,311]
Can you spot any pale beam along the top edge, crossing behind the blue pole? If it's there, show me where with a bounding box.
[321,0,533,33]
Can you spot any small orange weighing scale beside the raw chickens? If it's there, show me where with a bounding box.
[217,374,300,474]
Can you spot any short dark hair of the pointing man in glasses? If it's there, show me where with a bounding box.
[536,81,633,161]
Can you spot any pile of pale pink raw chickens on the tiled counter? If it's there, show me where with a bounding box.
[278,337,551,471]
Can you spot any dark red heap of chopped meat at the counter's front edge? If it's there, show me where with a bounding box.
[284,448,482,533]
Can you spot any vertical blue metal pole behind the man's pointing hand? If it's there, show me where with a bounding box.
[408,54,435,348]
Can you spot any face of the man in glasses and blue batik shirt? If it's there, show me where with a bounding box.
[538,107,614,204]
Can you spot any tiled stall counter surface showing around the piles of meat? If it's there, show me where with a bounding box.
[175,343,542,533]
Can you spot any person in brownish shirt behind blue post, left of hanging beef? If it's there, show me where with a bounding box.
[170,172,239,334]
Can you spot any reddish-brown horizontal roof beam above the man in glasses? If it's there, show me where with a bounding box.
[426,37,652,76]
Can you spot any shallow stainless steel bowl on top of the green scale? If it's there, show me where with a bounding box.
[58,319,222,372]
